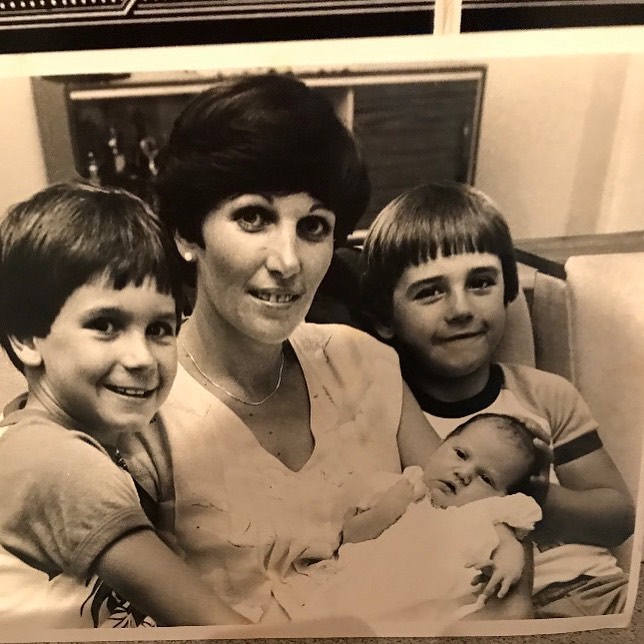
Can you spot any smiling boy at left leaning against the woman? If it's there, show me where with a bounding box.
[0,184,245,632]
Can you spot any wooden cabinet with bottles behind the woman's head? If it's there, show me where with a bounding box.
[32,66,485,228]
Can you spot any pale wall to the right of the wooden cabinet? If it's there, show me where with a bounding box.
[476,54,644,238]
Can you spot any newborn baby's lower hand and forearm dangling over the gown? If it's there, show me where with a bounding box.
[472,524,525,599]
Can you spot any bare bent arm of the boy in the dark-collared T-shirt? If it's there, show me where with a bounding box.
[535,447,635,548]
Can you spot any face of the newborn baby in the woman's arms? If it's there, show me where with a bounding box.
[425,418,531,507]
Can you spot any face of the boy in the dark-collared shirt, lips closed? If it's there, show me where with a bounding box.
[391,253,505,378]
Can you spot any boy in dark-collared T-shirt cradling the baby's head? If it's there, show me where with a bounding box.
[362,183,634,617]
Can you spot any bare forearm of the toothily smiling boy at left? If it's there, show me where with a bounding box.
[94,530,248,626]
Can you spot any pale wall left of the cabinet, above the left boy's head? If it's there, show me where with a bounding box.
[0,77,47,218]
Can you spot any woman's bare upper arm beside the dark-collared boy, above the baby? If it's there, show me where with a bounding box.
[398,382,441,469]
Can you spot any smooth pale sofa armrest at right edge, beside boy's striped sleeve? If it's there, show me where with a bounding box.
[566,253,644,565]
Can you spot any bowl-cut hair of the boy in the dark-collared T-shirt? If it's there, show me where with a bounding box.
[361,182,519,322]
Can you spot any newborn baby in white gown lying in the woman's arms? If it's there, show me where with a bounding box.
[289,414,541,630]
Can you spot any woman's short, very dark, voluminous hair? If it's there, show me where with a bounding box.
[157,73,371,245]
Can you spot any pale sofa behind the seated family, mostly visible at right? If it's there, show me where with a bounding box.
[0,253,644,564]
